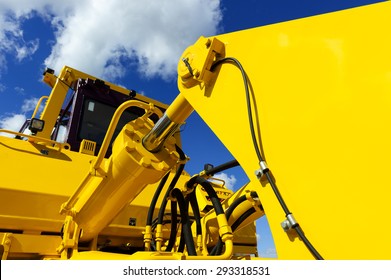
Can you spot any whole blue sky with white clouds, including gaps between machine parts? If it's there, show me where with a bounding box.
[0,0,381,257]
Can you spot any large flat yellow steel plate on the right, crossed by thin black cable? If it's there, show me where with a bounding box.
[178,2,391,259]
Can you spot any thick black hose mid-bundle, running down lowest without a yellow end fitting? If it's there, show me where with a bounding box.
[171,189,197,256]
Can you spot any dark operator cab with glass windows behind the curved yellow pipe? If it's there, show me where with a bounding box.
[20,75,165,157]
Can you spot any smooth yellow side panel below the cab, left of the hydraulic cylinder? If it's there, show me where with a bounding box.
[0,136,92,196]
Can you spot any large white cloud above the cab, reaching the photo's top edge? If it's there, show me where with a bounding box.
[45,0,221,79]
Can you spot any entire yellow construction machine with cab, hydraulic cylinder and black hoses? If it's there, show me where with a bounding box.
[0,2,391,260]
